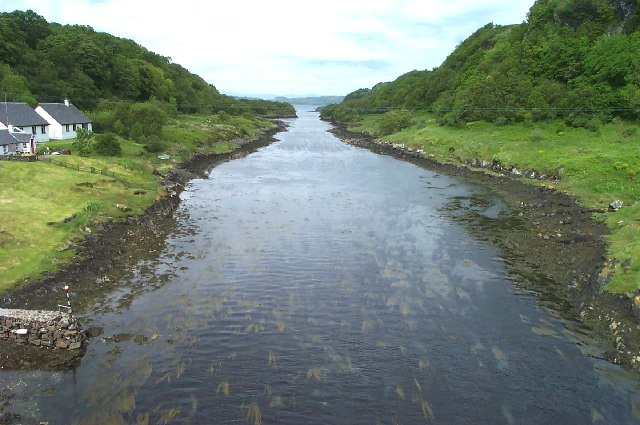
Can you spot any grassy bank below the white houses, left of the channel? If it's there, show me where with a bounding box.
[0,115,274,291]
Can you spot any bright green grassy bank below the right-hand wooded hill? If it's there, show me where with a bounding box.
[351,113,640,294]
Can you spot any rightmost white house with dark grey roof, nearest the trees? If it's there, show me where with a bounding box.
[35,99,92,140]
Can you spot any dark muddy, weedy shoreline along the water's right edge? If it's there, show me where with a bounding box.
[332,123,640,374]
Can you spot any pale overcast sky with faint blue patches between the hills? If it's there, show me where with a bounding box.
[0,0,533,95]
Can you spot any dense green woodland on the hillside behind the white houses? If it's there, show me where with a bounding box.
[0,10,292,115]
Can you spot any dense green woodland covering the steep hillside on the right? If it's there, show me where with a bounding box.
[323,0,640,128]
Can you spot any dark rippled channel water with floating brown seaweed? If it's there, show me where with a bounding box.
[5,110,640,424]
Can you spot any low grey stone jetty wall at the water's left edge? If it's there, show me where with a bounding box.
[0,308,87,351]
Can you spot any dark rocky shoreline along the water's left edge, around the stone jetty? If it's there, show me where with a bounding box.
[0,121,286,370]
